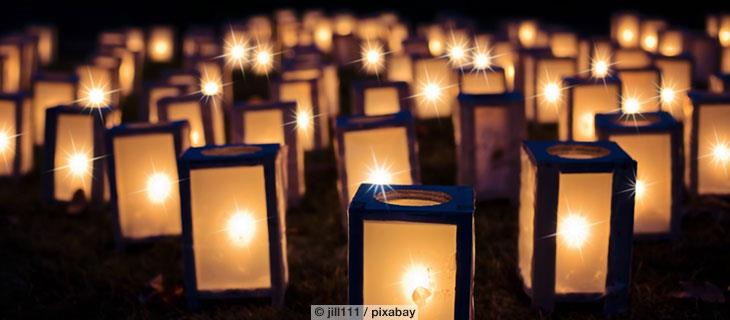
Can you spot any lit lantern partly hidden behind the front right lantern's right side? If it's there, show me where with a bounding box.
[596,112,684,238]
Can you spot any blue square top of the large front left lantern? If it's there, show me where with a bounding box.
[181,144,279,168]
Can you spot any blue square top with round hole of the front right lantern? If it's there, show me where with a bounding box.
[524,141,636,173]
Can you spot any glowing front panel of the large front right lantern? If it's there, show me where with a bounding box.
[555,173,613,294]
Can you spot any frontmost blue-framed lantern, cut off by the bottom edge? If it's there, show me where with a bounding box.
[348,184,474,320]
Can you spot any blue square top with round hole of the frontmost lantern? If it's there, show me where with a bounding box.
[349,183,474,218]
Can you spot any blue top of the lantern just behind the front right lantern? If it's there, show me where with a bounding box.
[595,111,679,134]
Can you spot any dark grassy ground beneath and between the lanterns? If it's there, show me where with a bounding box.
[0,66,730,319]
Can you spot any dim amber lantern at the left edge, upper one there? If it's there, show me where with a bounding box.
[0,34,37,93]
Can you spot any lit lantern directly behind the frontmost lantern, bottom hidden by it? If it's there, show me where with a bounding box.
[335,111,421,223]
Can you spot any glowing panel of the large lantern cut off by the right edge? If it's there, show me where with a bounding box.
[696,104,730,195]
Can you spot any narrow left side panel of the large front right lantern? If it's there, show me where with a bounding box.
[517,150,537,289]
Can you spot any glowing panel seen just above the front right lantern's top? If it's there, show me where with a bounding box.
[572,85,621,141]
